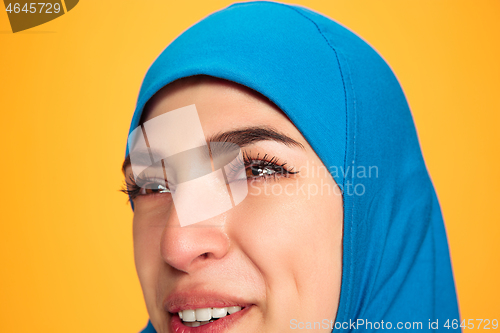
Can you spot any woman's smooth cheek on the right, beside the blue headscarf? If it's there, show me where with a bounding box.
[232,179,343,320]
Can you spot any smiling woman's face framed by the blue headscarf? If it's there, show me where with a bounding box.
[125,78,343,333]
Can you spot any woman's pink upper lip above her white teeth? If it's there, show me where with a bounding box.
[163,291,251,313]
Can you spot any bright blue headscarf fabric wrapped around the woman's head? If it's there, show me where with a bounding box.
[127,2,460,332]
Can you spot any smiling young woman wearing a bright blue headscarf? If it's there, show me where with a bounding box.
[124,2,459,333]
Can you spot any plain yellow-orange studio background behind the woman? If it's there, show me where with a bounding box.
[0,0,500,333]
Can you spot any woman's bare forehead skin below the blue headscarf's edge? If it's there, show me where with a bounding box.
[141,77,301,139]
